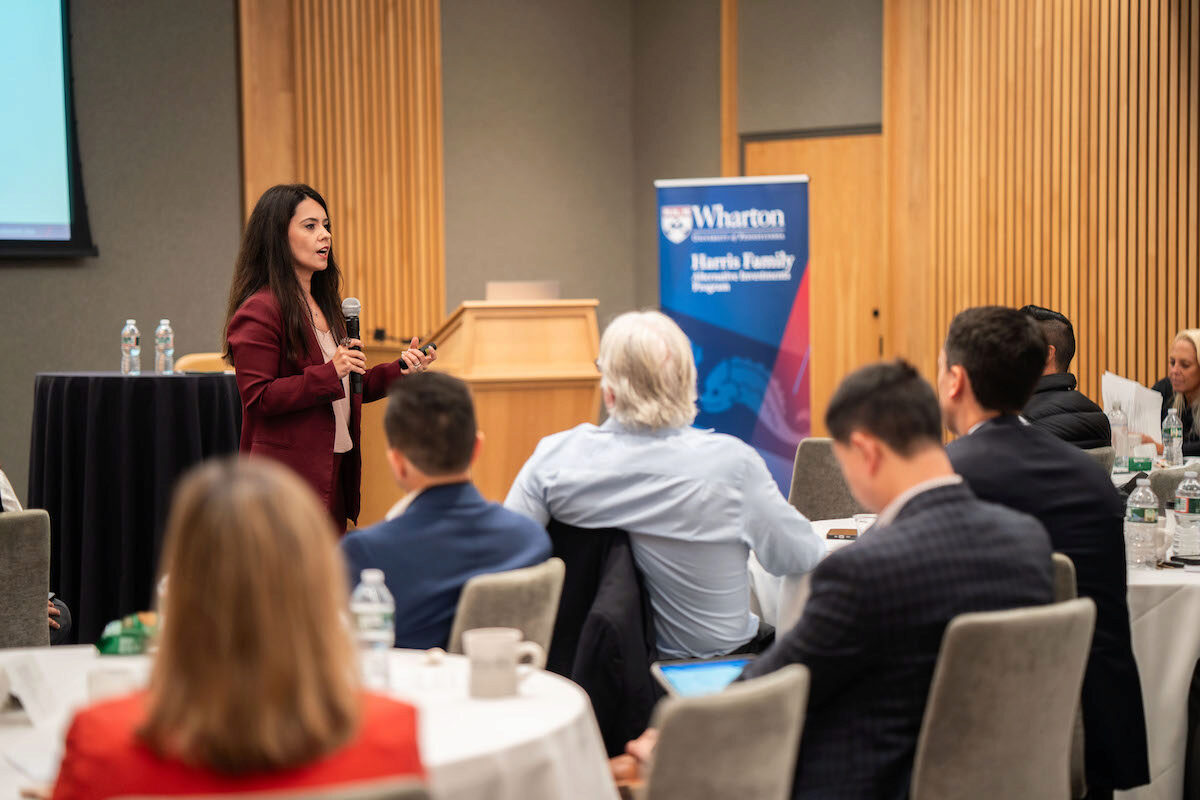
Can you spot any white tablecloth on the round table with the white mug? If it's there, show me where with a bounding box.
[0,646,617,800]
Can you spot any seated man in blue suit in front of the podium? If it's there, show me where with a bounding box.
[342,372,551,649]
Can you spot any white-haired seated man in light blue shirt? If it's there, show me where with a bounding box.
[504,311,824,658]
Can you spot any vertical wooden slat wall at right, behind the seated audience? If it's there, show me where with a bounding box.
[883,0,1200,397]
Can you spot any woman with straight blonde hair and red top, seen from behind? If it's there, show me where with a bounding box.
[53,459,422,800]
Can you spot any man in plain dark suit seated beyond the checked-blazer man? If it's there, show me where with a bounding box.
[937,306,1147,798]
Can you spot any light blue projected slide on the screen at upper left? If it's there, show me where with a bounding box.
[0,0,71,241]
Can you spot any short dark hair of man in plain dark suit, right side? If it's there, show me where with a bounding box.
[946,306,1049,414]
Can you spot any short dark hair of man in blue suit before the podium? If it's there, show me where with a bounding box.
[383,372,475,476]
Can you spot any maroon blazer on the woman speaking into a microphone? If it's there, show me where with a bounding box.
[228,289,401,523]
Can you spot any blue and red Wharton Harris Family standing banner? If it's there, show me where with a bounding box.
[654,175,811,495]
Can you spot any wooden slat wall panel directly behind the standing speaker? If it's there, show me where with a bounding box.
[239,0,445,344]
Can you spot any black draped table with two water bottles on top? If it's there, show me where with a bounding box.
[29,372,241,643]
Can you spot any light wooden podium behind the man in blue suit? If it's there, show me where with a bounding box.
[359,300,600,525]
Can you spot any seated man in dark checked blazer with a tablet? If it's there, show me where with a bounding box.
[614,362,1054,800]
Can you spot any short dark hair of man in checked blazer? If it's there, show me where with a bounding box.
[826,359,942,456]
